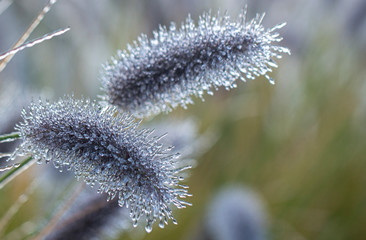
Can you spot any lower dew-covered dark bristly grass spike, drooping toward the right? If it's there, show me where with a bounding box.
[15,96,189,232]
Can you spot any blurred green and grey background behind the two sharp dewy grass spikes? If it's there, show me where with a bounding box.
[0,0,366,240]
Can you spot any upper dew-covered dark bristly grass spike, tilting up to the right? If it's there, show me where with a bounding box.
[101,8,289,117]
